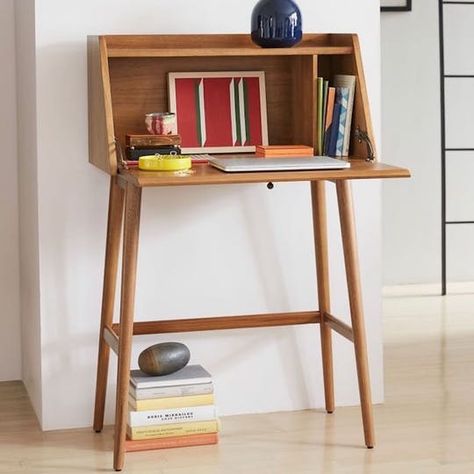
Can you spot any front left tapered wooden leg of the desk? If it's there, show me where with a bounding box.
[114,184,141,471]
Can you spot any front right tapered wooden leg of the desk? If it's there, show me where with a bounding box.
[336,180,375,448]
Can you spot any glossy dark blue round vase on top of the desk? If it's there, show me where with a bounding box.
[251,0,303,48]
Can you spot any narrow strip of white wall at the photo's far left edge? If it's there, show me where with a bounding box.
[0,0,21,381]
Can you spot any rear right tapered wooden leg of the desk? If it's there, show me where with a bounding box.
[311,181,334,413]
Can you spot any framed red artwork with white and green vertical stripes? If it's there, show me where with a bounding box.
[168,71,268,153]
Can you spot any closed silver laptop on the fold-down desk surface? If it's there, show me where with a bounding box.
[209,156,351,173]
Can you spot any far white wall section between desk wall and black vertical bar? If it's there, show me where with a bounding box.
[381,0,441,285]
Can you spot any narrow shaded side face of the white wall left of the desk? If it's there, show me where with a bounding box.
[12,0,42,419]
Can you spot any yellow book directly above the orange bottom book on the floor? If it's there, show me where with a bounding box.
[127,420,219,440]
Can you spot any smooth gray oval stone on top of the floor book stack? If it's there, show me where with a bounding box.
[138,342,191,375]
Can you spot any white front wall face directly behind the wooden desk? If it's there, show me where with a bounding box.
[30,0,383,429]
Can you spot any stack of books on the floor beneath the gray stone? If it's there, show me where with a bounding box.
[127,365,218,451]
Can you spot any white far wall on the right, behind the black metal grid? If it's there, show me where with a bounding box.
[381,0,474,285]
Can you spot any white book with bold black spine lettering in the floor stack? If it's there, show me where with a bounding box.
[128,405,217,427]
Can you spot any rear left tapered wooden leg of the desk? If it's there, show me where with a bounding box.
[94,176,124,433]
